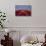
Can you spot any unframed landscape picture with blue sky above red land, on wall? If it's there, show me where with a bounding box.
[15,5,32,16]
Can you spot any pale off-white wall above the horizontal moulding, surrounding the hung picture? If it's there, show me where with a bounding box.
[0,0,46,27]
